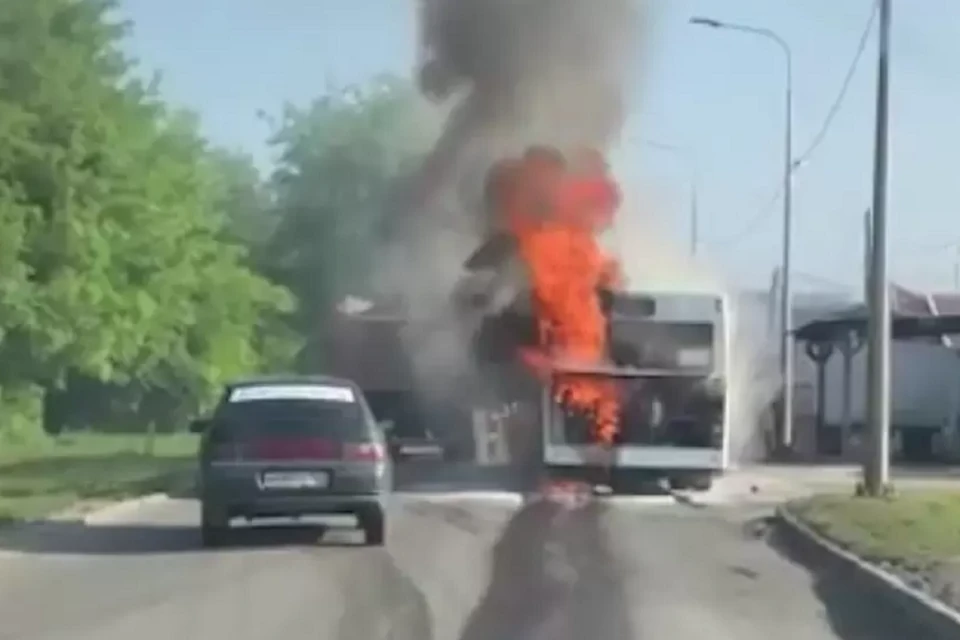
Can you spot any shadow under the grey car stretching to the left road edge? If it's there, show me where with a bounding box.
[0,522,372,555]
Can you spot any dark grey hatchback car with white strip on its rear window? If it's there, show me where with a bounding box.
[191,376,392,546]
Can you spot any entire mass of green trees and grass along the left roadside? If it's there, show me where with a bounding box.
[0,0,430,518]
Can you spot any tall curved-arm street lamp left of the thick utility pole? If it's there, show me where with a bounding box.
[690,17,795,449]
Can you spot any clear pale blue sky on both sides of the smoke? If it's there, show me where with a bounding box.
[114,0,960,290]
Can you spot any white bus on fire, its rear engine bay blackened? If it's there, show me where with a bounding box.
[541,292,732,492]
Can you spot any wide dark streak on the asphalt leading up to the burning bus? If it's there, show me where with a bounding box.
[460,502,634,640]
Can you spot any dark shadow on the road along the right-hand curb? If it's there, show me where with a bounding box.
[757,519,935,640]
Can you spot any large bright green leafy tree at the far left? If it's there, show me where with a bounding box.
[0,0,292,436]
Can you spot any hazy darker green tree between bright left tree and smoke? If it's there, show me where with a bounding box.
[264,77,435,364]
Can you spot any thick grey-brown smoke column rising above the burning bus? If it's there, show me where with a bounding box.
[380,0,643,394]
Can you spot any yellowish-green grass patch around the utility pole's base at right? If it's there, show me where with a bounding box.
[789,490,960,570]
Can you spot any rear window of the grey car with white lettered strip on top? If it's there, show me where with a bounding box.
[214,385,372,442]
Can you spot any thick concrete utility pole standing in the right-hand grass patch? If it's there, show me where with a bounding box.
[863,0,891,496]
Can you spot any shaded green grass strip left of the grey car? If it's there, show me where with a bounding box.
[0,434,197,522]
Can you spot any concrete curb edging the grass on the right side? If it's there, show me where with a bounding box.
[775,505,960,640]
